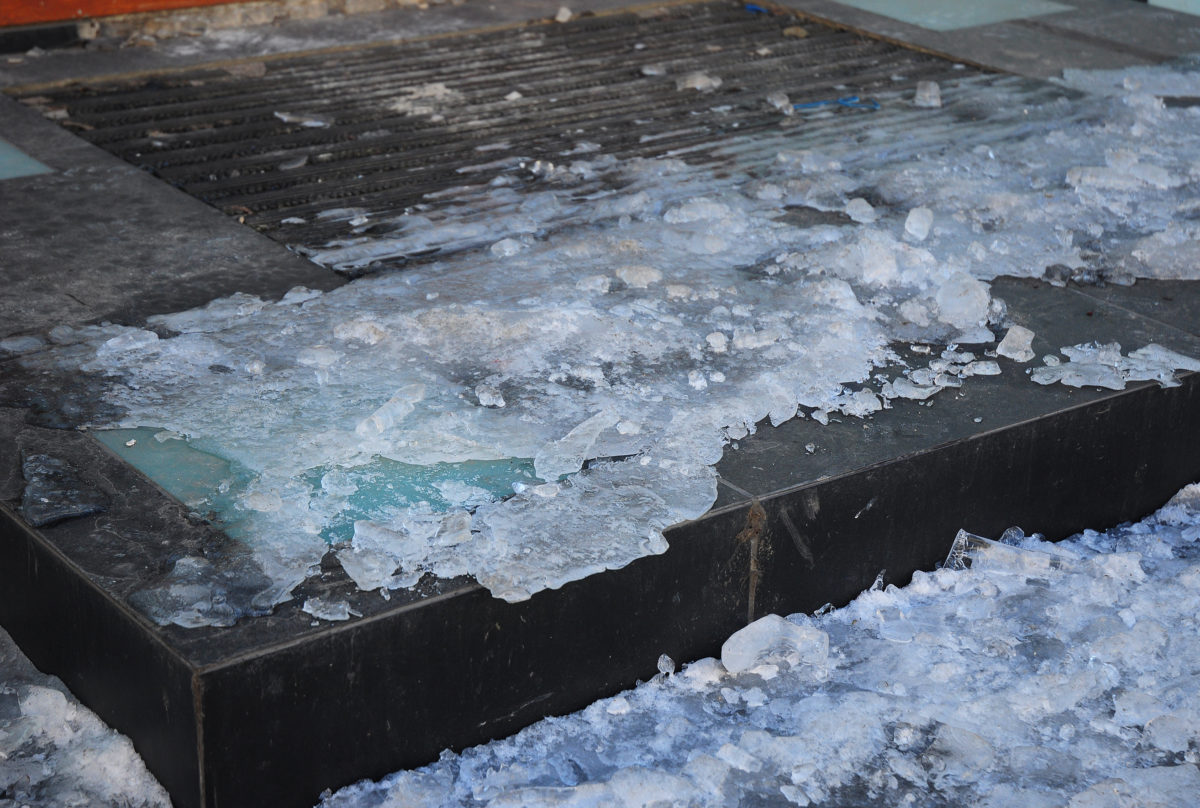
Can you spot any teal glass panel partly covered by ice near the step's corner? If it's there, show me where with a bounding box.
[92,426,540,544]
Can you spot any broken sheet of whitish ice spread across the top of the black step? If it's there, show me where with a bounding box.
[7,65,1200,626]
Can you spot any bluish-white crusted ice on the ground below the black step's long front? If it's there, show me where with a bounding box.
[320,485,1200,808]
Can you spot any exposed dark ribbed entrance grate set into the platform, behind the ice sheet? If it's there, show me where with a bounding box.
[14,2,979,271]
